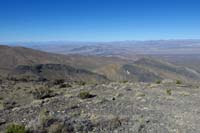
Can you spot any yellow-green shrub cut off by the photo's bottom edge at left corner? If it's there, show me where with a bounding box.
[6,124,27,133]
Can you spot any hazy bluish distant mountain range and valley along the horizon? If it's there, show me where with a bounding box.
[5,39,200,58]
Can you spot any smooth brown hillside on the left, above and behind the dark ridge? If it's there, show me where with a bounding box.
[0,45,126,73]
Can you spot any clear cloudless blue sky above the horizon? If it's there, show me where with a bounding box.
[0,0,200,42]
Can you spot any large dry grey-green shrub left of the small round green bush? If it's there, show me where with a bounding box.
[32,87,55,99]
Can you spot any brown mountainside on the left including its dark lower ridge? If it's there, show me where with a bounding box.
[0,45,125,82]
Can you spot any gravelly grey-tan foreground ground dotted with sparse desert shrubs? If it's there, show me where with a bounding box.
[0,81,200,133]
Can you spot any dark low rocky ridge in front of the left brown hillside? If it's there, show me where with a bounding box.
[9,64,107,82]
